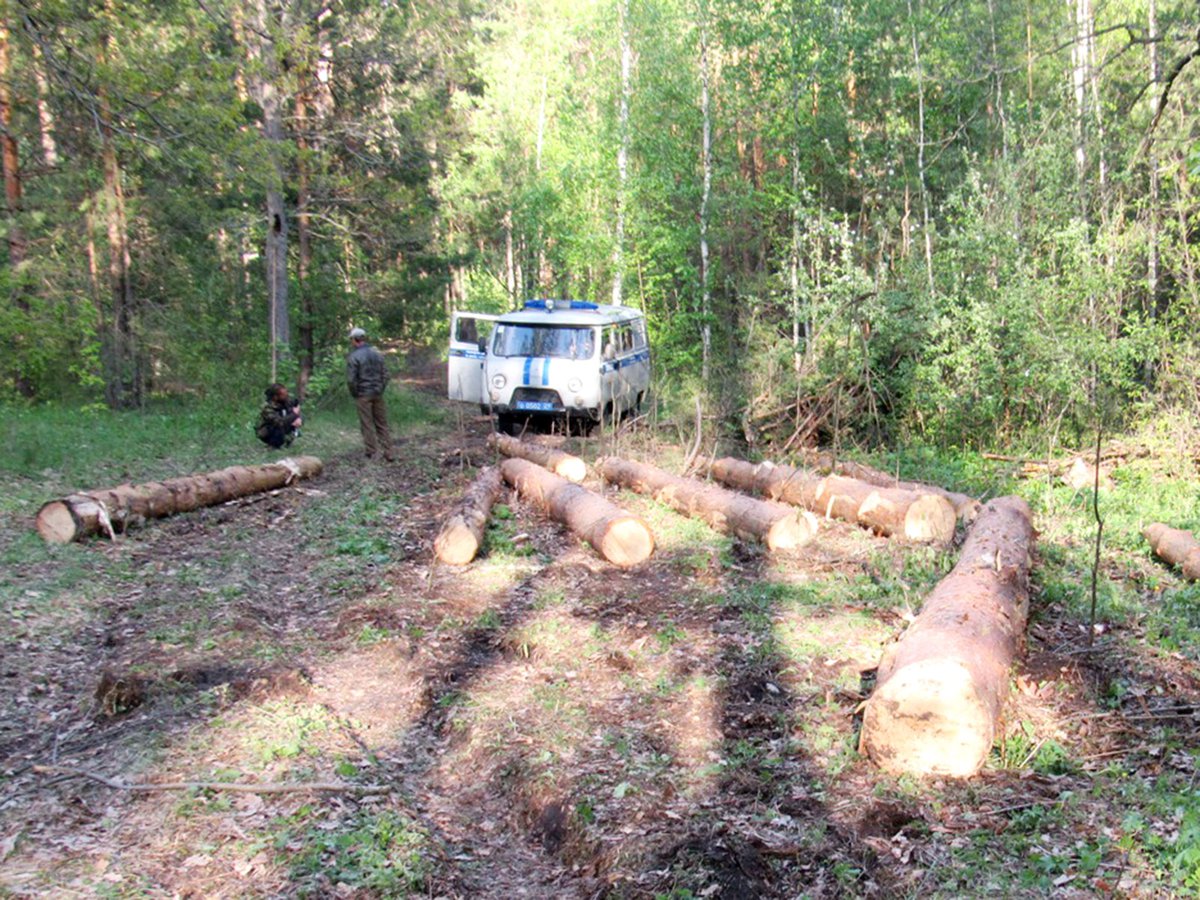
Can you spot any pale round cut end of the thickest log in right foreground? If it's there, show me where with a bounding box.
[862,658,995,778]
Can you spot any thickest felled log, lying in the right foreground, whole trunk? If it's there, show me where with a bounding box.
[860,497,1034,778]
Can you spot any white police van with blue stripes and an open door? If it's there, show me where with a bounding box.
[448,300,650,432]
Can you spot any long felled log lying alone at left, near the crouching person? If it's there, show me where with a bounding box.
[36,456,322,544]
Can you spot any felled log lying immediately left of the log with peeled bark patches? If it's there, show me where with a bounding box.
[600,457,817,551]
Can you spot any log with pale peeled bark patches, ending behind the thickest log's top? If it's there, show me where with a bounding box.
[712,457,956,544]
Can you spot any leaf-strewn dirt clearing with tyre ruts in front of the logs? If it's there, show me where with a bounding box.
[0,368,1200,898]
